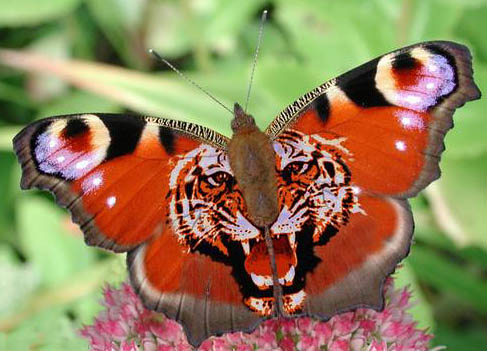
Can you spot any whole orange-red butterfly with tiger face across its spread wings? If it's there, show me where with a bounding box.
[13,41,480,346]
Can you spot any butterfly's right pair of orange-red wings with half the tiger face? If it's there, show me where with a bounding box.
[266,41,480,317]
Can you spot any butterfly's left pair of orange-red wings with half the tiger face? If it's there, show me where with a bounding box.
[14,114,260,344]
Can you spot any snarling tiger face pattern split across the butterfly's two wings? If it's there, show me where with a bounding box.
[168,130,363,316]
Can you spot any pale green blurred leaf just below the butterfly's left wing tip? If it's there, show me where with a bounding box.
[16,194,95,286]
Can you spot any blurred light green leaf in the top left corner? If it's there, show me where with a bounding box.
[0,0,81,27]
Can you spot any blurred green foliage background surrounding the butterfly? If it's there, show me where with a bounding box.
[0,0,487,351]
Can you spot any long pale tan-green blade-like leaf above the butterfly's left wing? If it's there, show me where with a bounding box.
[0,50,245,135]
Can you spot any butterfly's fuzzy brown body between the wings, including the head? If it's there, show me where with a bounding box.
[228,104,279,227]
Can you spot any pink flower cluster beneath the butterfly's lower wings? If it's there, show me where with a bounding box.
[80,280,440,351]
